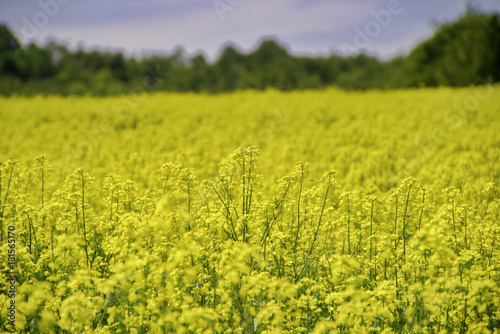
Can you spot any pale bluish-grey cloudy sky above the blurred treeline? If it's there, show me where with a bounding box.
[0,0,500,60]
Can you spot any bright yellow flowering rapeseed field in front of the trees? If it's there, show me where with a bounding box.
[0,86,500,333]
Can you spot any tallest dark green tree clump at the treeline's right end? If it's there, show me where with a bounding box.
[407,9,500,86]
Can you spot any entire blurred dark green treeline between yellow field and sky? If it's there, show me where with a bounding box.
[0,10,500,95]
